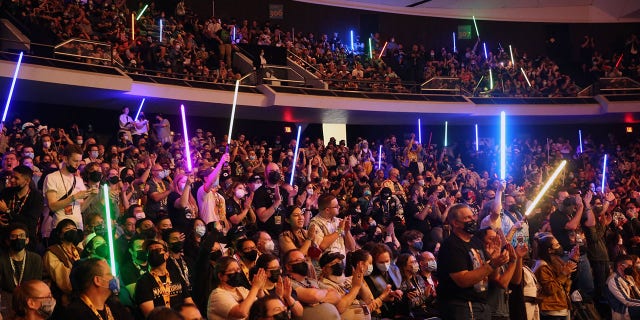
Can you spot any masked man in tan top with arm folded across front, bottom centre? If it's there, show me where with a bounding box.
[282,250,342,320]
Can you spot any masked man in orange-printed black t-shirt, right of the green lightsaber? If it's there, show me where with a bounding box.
[134,240,193,317]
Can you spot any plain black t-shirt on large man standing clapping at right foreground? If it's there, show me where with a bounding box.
[437,234,488,303]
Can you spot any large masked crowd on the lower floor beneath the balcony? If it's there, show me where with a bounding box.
[0,102,640,319]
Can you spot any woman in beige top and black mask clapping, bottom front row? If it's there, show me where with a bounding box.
[207,257,268,320]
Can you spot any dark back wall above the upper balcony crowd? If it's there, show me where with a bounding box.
[190,0,640,60]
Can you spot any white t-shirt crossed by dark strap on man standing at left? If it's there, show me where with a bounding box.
[42,171,87,230]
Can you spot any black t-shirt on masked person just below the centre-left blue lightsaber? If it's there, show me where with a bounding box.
[253,185,289,239]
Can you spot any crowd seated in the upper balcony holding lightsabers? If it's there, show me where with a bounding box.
[3,0,640,97]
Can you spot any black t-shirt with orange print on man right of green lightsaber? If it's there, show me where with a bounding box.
[135,270,189,307]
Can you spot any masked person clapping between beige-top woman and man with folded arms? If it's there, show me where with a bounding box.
[251,253,303,318]
